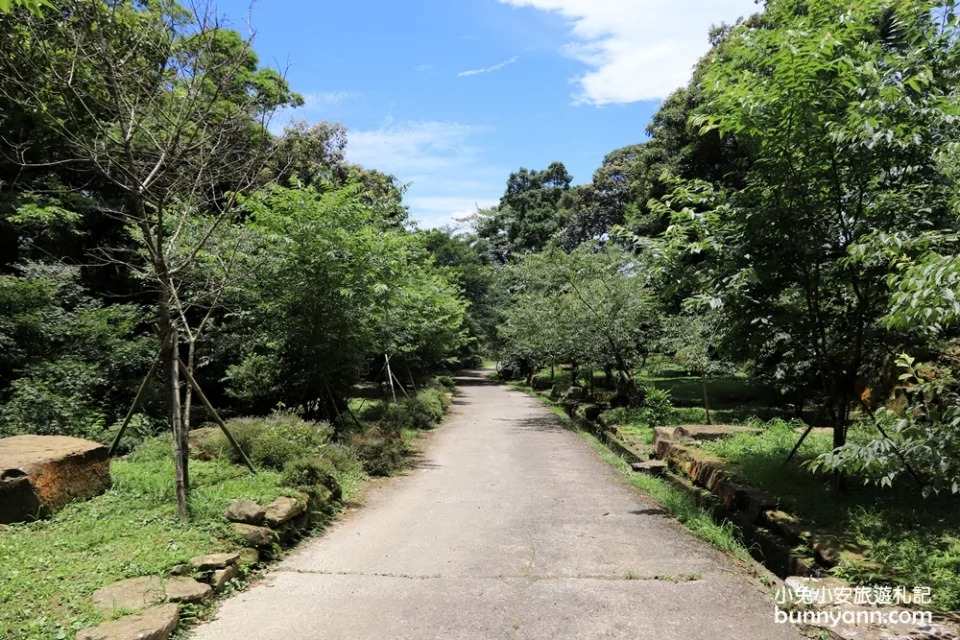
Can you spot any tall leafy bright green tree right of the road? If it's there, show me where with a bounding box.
[636,0,958,460]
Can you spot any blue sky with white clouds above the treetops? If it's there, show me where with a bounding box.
[217,0,757,226]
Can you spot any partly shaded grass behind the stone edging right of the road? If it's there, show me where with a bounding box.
[702,421,960,611]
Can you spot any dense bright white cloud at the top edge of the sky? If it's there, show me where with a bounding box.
[500,0,758,106]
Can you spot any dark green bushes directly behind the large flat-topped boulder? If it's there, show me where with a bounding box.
[0,263,152,440]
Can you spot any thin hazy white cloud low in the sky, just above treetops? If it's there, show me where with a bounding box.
[347,119,504,227]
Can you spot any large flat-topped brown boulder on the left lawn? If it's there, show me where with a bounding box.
[0,436,110,523]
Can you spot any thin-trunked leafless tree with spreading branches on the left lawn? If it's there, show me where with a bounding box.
[0,0,301,518]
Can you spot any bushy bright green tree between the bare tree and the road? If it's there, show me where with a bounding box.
[227,184,467,419]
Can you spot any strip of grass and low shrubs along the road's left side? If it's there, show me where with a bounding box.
[0,384,450,640]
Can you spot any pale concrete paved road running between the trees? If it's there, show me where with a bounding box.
[195,375,799,640]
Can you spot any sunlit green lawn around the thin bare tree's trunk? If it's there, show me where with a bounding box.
[0,459,287,640]
